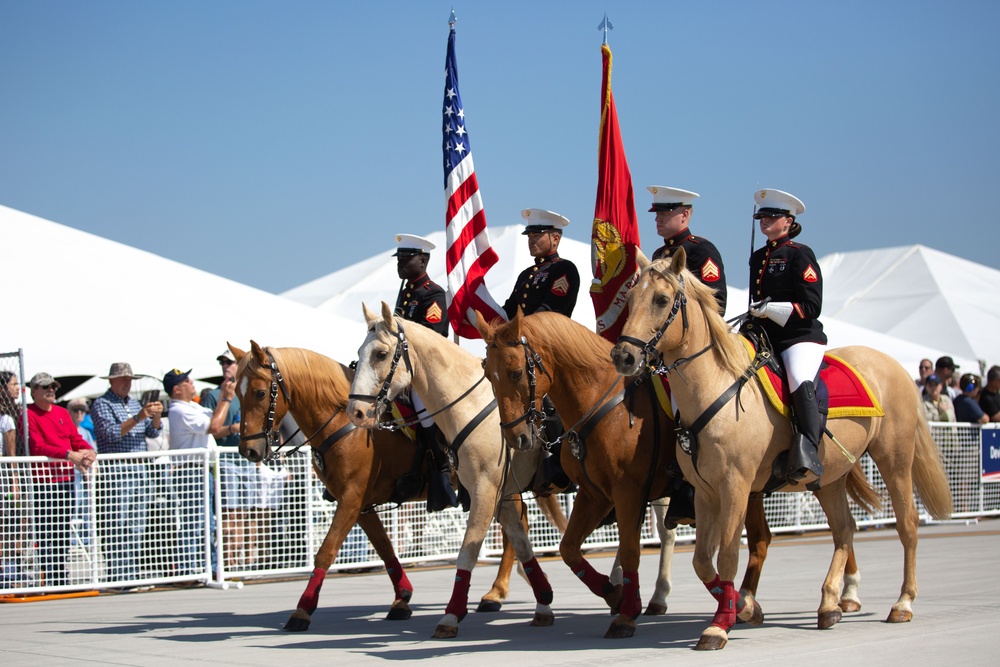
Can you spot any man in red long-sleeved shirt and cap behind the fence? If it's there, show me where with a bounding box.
[28,373,97,586]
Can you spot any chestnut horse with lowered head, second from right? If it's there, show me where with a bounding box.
[477,311,878,638]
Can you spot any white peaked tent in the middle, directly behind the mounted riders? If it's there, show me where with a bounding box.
[282,225,971,376]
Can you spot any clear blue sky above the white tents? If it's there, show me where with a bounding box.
[0,0,1000,292]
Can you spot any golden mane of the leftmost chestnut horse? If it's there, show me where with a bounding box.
[239,347,351,406]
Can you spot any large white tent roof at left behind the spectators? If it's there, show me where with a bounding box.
[0,206,365,400]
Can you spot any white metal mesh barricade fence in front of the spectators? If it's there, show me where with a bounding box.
[0,424,1000,595]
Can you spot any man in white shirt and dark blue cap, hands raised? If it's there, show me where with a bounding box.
[163,368,239,576]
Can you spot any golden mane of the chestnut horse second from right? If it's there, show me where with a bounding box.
[491,311,612,371]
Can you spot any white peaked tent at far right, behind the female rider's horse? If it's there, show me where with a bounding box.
[819,245,1000,372]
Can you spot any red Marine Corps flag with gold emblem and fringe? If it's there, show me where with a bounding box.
[590,25,639,342]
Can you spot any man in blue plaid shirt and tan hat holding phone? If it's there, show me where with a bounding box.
[90,362,163,582]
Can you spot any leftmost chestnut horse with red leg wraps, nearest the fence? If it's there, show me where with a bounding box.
[229,341,566,631]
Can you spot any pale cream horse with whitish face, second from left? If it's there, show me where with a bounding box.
[347,302,555,638]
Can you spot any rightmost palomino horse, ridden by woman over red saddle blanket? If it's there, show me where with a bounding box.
[612,250,951,649]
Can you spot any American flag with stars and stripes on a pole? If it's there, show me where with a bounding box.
[441,25,506,338]
